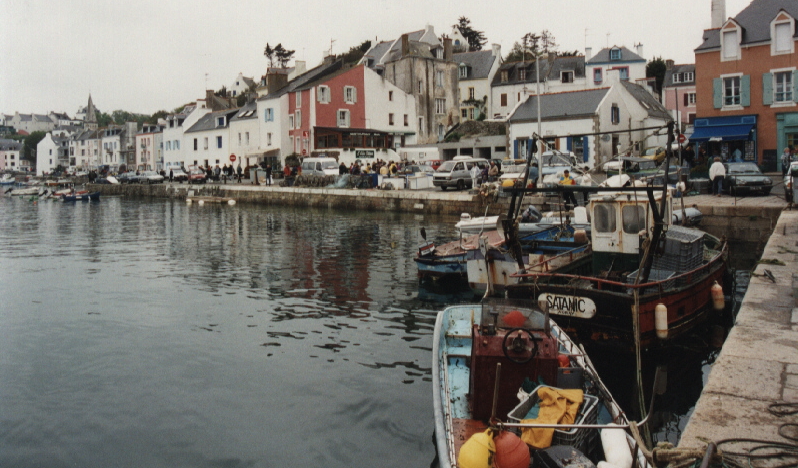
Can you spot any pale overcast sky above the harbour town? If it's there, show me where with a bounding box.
[0,0,750,116]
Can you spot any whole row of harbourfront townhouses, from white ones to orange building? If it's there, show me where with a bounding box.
[20,0,798,173]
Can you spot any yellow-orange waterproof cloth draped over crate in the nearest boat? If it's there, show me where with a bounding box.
[521,387,584,449]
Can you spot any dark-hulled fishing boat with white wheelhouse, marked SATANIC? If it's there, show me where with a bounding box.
[506,126,728,347]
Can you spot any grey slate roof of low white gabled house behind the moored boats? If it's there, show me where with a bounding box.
[508,88,610,122]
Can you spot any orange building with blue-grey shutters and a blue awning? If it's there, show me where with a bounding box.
[690,0,798,171]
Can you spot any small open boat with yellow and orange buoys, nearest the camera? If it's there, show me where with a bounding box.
[432,300,653,468]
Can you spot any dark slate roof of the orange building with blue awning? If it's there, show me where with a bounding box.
[695,0,798,52]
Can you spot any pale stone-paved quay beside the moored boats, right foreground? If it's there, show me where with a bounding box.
[679,207,798,466]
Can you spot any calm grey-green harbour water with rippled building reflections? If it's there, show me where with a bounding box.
[0,197,760,468]
